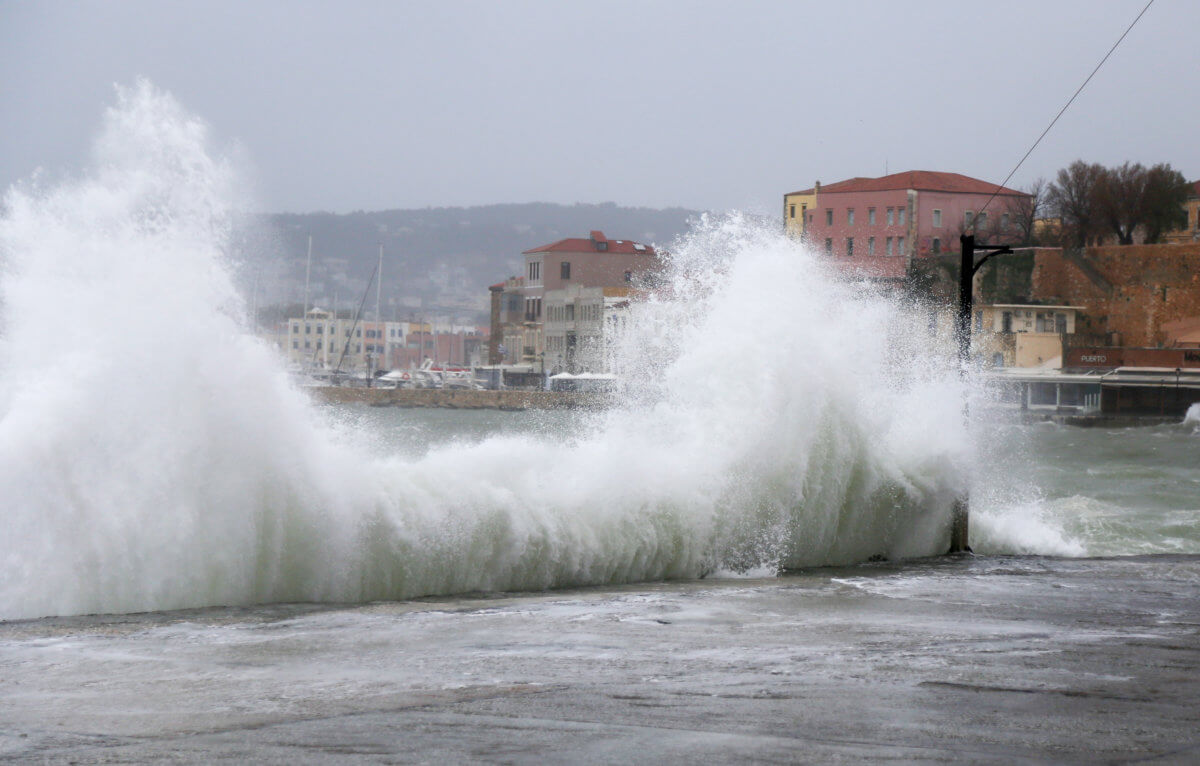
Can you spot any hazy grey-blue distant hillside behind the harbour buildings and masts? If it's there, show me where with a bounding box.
[256,203,700,317]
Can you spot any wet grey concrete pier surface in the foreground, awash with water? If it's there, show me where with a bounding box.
[0,556,1200,764]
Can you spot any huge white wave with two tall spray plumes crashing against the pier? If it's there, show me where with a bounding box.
[0,83,1065,618]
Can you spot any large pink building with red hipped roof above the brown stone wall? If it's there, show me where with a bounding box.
[804,170,1027,279]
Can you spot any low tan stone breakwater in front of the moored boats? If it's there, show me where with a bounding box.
[308,387,613,409]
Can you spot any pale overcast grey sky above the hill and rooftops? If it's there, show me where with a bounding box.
[0,0,1200,213]
